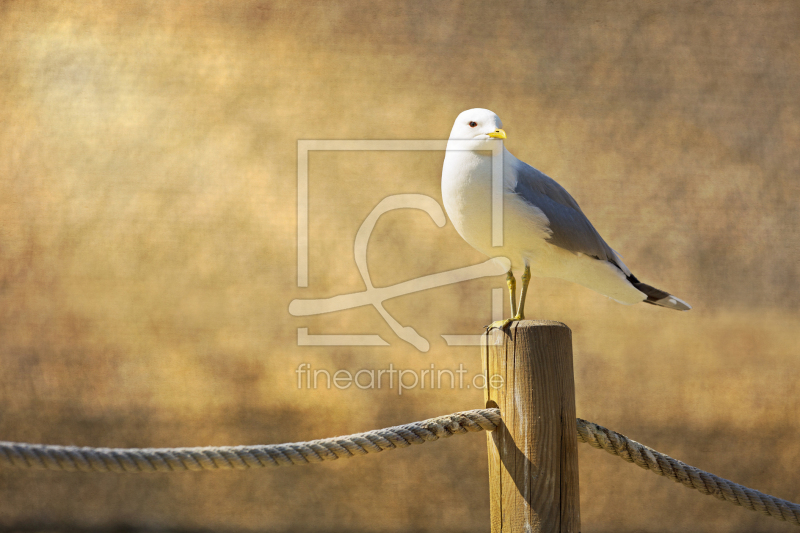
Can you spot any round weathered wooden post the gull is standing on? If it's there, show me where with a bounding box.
[482,320,581,533]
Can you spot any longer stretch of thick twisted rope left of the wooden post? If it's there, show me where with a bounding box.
[0,409,501,473]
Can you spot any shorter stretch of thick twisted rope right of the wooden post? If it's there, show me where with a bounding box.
[578,418,800,526]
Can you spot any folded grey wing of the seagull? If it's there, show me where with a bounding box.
[514,161,619,266]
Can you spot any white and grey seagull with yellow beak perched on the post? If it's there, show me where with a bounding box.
[442,109,691,329]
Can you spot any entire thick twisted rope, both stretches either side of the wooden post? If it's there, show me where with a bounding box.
[0,409,800,526]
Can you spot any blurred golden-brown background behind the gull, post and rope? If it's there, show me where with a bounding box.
[0,0,800,532]
